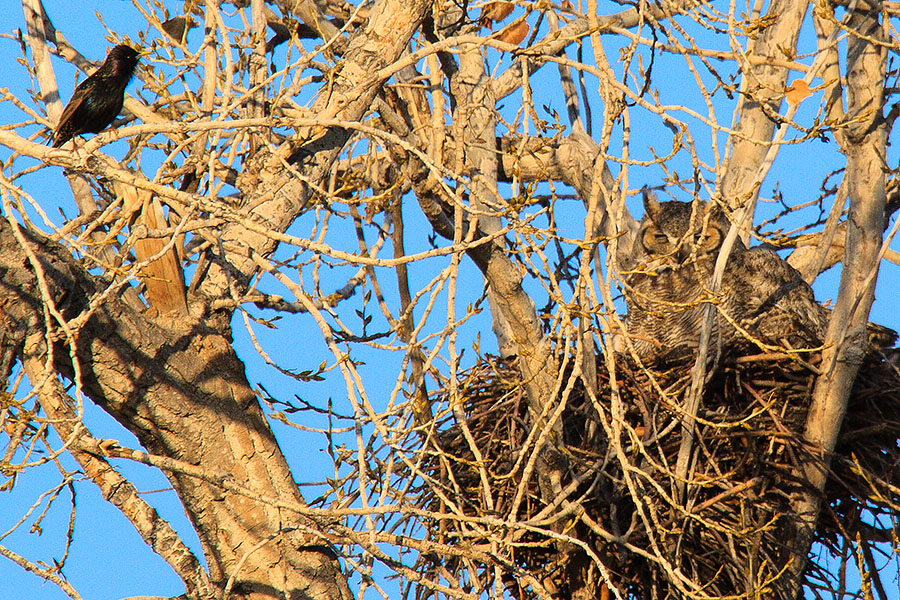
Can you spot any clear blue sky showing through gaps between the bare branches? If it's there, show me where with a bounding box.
[0,0,900,600]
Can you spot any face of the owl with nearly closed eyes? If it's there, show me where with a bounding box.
[638,194,728,273]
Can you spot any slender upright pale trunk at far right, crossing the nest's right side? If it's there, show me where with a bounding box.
[784,7,887,597]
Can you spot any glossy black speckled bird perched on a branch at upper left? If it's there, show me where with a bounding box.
[52,44,141,148]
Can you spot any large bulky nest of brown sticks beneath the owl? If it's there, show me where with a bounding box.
[419,346,900,600]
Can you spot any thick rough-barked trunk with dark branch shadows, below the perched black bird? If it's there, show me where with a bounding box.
[0,221,351,600]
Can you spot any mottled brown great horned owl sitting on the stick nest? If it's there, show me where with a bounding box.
[624,194,828,360]
